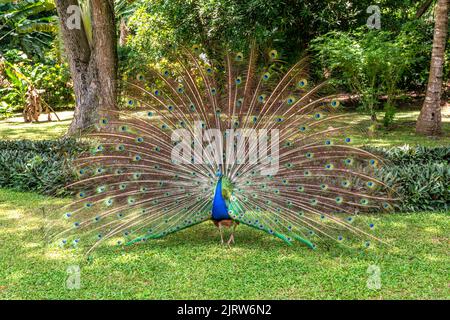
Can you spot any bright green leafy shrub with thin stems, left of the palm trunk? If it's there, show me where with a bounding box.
[311,23,431,127]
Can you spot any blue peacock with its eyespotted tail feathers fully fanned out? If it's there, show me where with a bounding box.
[50,45,393,252]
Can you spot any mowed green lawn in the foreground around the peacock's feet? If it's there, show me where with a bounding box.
[0,190,450,299]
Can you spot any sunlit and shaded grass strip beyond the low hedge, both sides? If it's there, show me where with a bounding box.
[0,108,450,147]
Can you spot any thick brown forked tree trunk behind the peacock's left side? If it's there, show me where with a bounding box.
[56,0,118,134]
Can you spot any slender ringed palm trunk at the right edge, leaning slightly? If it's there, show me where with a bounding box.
[416,0,449,135]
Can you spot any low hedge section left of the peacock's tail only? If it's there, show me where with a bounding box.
[0,139,87,195]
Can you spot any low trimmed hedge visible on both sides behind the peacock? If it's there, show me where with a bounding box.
[0,138,450,212]
